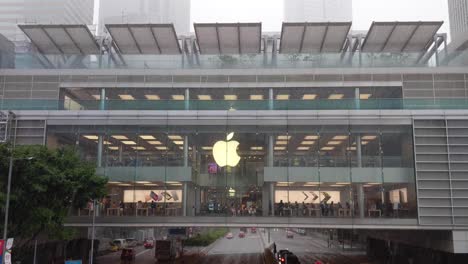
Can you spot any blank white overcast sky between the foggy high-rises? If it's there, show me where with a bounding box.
[191,0,449,32]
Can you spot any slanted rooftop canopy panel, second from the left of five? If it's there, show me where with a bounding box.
[106,24,182,54]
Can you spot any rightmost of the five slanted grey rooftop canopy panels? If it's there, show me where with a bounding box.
[361,21,443,52]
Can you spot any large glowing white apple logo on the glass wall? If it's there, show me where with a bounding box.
[213,132,240,167]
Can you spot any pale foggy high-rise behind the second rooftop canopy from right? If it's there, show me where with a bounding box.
[284,0,353,22]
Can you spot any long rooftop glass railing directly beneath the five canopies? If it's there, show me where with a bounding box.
[5,51,468,69]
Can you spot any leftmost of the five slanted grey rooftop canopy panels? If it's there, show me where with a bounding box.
[18,24,100,55]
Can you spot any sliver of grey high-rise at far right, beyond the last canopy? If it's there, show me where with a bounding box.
[448,0,468,40]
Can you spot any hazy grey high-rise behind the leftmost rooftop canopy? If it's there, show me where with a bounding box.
[0,0,94,41]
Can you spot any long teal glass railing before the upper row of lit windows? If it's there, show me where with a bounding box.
[0,99,468,111]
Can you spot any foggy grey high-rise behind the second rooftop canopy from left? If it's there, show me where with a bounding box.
[98,0,190,34]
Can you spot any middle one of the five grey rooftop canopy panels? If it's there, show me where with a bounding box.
[194,23,262,54]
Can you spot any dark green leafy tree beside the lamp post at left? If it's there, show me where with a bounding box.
[0,144,107,246]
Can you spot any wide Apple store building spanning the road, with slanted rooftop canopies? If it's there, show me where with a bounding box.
[0,21,468,253]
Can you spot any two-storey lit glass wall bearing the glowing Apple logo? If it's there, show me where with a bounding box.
[47,124,417,219]
